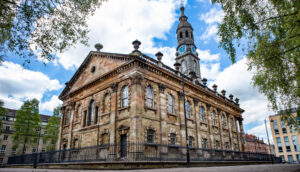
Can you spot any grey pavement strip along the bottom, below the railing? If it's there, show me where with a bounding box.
[0,164,300,172]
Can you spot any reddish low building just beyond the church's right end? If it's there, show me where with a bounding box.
[245,134,274,154]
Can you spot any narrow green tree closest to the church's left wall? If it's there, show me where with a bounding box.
[43,106,61,151]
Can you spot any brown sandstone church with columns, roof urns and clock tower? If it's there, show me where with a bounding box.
[57,7,244,155]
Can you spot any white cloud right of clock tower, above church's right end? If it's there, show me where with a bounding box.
[211,58,274,124]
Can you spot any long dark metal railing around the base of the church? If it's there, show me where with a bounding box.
[8,143,281,164]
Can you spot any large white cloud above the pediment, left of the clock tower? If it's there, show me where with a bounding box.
[58,0,186,69]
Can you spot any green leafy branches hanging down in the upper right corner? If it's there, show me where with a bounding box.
[212,0,300,128]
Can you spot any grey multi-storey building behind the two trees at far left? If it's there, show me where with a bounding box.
[0,109,51,164]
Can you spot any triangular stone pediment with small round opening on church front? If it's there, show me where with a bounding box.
[60,52,131,97]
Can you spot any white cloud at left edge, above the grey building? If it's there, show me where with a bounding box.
[0,61,62,109]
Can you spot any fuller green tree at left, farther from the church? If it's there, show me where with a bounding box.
[13,99,41,154]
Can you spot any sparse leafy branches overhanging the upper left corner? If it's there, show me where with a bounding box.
[0,0,105,64]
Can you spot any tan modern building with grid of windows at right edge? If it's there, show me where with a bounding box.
[269,110,300,162]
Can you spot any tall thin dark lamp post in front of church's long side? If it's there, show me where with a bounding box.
[174,62,192,167]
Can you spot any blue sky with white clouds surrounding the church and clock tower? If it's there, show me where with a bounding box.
[0,0,275,142]
